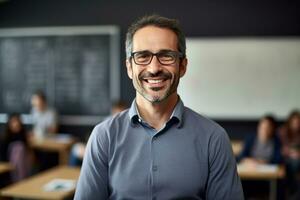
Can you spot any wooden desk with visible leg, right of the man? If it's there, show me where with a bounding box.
[237,164,285,200]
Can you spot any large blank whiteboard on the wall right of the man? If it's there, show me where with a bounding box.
[178,37,300,119]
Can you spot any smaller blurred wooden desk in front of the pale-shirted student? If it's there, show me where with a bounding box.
[29,135,75,165]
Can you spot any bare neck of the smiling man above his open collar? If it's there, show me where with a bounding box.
[136,93,178,130]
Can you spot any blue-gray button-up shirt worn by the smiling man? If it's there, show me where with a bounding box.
[74,100,244,200]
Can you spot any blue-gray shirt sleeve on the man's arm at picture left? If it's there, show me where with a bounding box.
[74,125,108,200]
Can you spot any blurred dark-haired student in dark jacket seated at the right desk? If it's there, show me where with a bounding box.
[237,116,282,167]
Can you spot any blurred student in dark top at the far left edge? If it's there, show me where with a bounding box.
[0,114,31,182]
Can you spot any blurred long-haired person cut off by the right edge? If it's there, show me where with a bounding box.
[279,110,300,197]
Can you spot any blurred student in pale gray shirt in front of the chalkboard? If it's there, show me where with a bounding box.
[31,91,58,138]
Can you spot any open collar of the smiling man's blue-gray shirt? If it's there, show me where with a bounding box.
[129,97,184,128]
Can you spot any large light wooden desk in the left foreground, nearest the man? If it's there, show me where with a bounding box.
[0,166,80,200]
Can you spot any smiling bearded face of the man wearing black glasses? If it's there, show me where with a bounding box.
[126,26,187,103]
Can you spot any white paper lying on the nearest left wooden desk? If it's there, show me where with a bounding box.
[43,179,76,192]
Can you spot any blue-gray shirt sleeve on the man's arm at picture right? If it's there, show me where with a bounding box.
[206,127,244,200]
